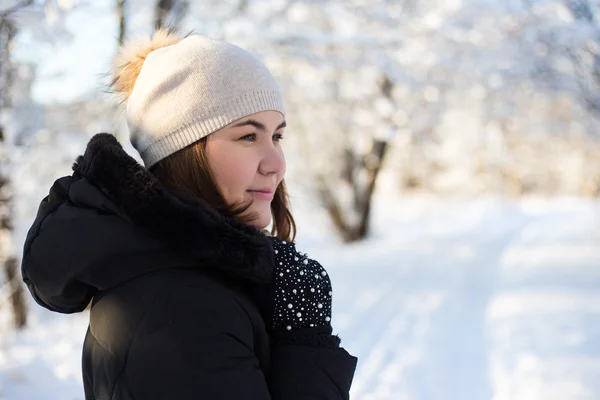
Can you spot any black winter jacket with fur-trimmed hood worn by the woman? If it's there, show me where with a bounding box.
[22,134,357,400]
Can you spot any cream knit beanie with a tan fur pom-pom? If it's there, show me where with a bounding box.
[115,31,285,168]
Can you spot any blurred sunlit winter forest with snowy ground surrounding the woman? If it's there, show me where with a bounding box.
[0,0,600,400]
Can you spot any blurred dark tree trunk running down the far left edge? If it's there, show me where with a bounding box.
[0,0,33,328]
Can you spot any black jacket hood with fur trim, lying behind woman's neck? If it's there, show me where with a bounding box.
[22,133,273,313]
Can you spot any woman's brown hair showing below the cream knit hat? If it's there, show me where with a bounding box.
[150,137,296,241]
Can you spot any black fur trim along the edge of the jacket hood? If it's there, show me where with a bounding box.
[73,133,274,284]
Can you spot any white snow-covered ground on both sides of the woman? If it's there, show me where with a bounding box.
[0,198,600,400]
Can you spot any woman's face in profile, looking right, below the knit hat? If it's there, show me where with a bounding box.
[206,111,285,229]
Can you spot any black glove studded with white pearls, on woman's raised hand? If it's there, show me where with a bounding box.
[271,238,340,347]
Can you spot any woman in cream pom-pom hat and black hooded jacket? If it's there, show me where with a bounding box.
[22,31,357,400]
